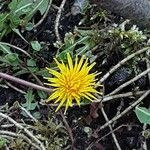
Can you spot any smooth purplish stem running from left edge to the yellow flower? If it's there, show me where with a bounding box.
[0,72,52,93]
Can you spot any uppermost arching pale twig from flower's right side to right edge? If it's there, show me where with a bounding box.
[98,47,150,84]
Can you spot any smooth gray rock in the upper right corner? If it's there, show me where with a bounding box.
[91,0,150,28]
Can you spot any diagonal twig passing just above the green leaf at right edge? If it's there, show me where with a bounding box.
[98,90,150,131]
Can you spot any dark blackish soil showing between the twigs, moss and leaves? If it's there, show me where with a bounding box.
[0,0,150,150]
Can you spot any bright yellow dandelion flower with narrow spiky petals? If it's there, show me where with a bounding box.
[46,53,102,112]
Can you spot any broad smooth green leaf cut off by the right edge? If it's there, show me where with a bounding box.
[135,107,150,124]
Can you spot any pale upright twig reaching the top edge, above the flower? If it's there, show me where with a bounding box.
[55,0,66,42]
